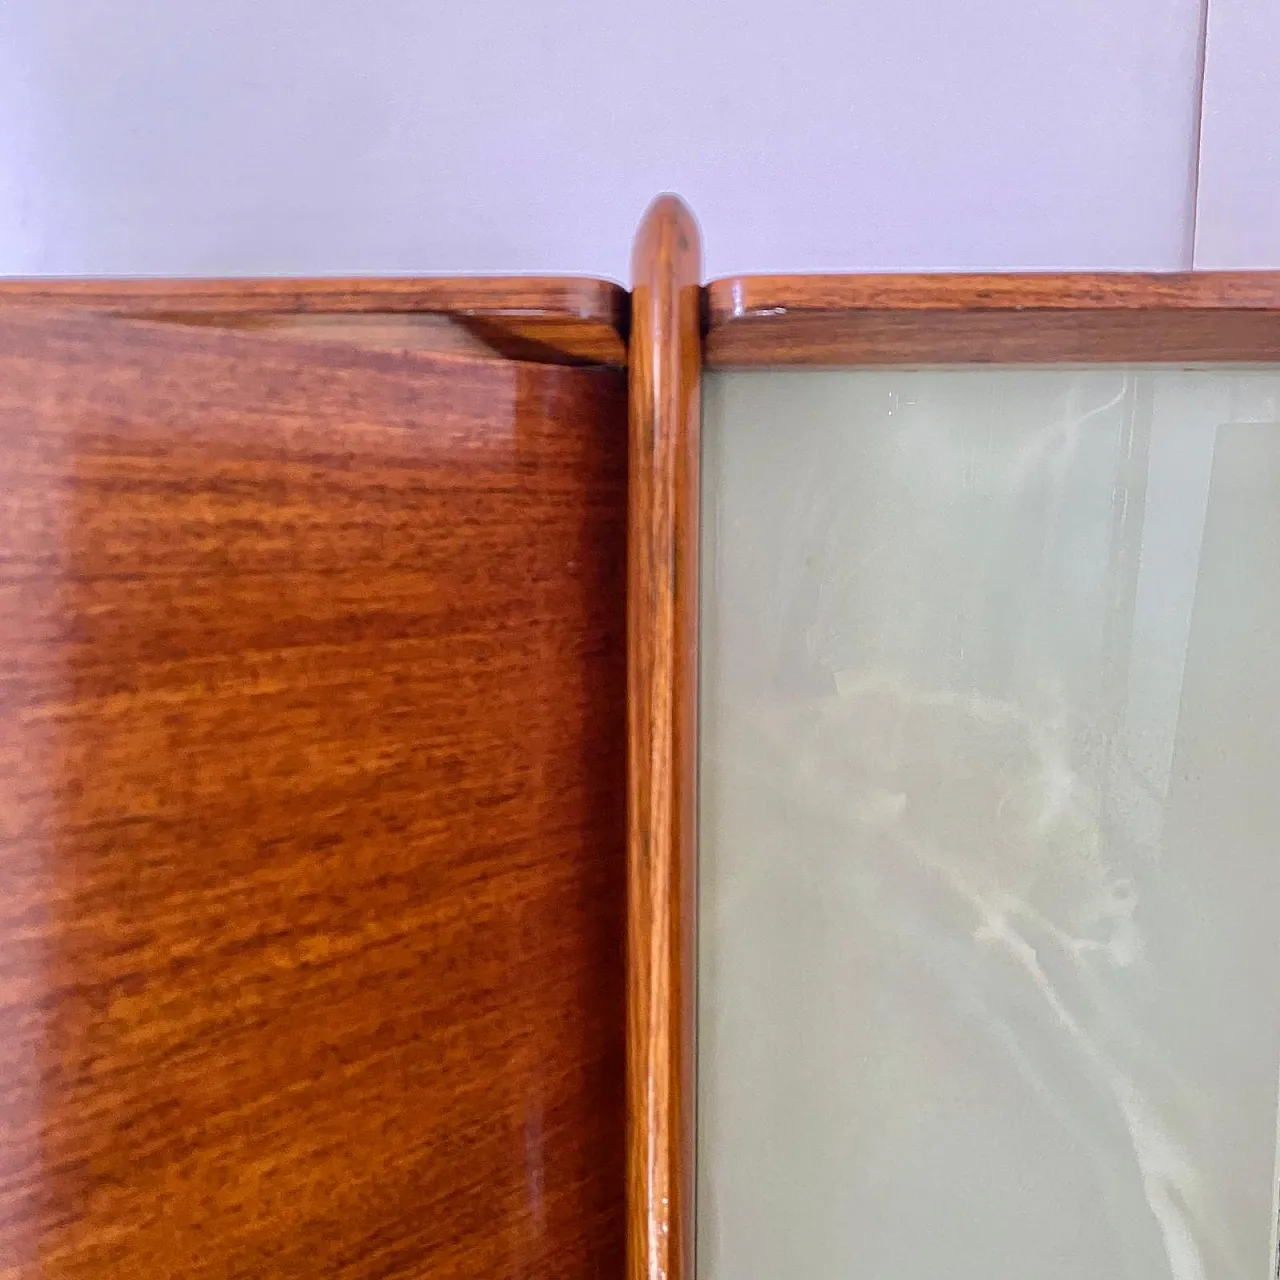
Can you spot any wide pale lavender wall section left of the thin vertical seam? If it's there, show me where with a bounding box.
[0,0,1213,278]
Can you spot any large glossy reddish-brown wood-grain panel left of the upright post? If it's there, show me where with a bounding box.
[0,308,626,1280]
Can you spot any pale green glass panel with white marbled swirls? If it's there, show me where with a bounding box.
[698,367,1280,1280]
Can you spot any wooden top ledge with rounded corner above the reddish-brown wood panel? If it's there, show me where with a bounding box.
[0,276,628,366]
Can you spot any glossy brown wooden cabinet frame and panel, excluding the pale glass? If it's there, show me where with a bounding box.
[0,196,1280,1280]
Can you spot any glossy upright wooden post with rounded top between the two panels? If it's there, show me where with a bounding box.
[627,196,701,1280]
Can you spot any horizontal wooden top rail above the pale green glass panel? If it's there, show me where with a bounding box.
[707,271,1280,369]
